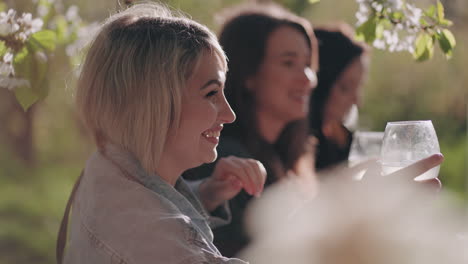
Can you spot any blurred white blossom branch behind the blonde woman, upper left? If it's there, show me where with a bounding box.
[0,0,97,110]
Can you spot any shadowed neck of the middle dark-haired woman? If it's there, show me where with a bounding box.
[257,109,287,144]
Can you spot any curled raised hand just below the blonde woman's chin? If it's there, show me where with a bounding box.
[199,156,266,211]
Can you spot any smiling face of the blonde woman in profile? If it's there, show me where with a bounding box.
[163,52,235,170]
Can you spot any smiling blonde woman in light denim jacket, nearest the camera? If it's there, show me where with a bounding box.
[57,4,266,263]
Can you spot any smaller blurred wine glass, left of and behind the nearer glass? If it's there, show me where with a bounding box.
[348,131,384,180]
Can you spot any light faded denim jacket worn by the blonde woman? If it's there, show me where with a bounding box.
[64,146,246,264]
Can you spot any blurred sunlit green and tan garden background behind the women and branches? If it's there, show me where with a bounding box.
[0,0,468,264]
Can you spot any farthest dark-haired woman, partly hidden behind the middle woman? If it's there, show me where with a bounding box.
[309,24,369,170]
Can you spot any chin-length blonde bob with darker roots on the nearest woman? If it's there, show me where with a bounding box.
[76,4,227,172]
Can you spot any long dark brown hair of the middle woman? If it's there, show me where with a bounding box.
[219,4,318,182]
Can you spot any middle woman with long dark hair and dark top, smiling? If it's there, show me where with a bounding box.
[186,4,318,256]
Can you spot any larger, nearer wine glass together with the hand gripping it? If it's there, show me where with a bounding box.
[356,121,444,191]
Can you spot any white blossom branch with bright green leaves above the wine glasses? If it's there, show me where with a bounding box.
[356,0,456,61]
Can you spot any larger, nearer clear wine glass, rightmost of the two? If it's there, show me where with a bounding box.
[380,120,440,180]
